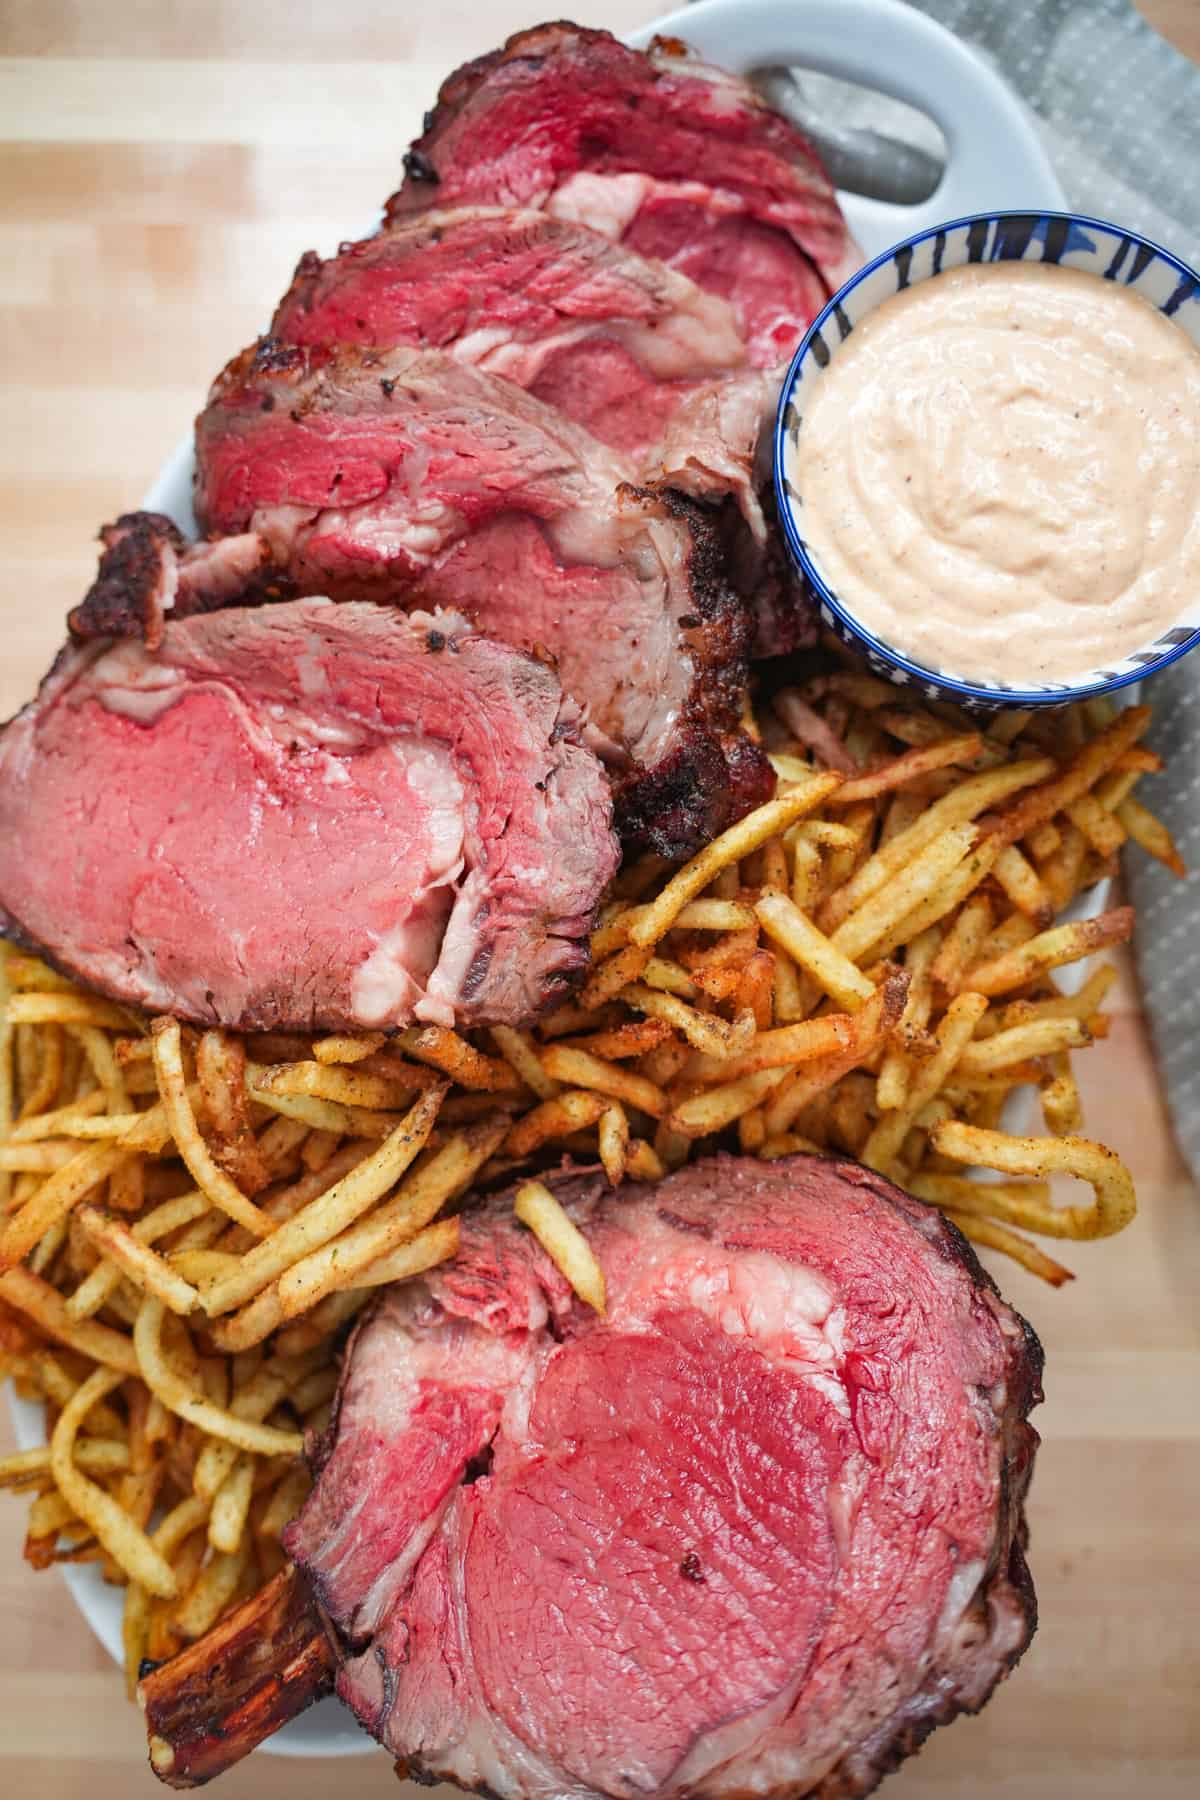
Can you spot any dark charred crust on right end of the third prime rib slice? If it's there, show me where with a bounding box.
[615,488,775,859]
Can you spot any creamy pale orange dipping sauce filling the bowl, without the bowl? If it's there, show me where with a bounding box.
[793,263,1200,686]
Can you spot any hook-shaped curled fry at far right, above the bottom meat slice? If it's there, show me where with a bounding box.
[930,1120,1137,1238]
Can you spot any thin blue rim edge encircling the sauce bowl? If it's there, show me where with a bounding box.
[774,207,1200,707]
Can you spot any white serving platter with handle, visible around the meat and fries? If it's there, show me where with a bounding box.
[9,0,1057,1757]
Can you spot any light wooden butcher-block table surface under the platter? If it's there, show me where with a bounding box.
[0,0,1200,1800]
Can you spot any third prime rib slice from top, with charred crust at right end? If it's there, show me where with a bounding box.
[196,338,772,855]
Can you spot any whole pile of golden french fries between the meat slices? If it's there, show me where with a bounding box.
[0,668,1178,1690]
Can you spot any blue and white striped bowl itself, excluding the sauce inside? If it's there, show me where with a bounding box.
[775,212,1200,713]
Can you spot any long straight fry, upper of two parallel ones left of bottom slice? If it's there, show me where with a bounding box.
[201,1089,444,1318]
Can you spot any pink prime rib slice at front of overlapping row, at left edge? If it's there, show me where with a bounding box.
[0,599,617,1030]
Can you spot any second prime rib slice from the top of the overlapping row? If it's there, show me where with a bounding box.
[272,207,765,482]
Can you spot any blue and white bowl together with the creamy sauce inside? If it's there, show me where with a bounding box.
[775,212,1200,711]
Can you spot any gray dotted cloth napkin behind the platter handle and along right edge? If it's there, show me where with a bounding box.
[770,0,1200,1175]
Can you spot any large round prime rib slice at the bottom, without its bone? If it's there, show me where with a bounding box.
[286,1157,1042,1800]
